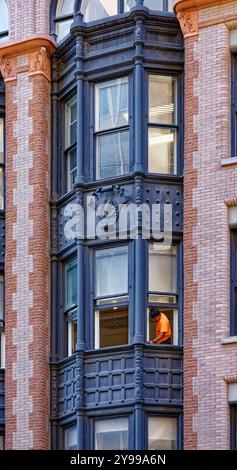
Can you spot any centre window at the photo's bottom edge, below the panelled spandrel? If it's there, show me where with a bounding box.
[95,418,128,450]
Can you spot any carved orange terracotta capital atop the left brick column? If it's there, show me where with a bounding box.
[0,35,56,82]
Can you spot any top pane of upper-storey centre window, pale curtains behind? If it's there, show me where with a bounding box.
[95,77,128,131]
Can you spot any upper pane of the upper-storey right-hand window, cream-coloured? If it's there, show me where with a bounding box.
[149,75,176,125]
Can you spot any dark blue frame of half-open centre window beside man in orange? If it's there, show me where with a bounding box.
[92,242,133,351]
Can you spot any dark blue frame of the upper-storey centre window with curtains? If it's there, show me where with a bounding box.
[93,75,131,182]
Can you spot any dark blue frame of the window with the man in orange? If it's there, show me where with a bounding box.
[145,239,183,347]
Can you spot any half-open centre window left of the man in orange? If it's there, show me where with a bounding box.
[95,247,128,348]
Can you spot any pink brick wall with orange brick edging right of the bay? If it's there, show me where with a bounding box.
[177,1,237,449]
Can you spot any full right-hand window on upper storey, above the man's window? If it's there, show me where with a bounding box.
[148,75,177,174]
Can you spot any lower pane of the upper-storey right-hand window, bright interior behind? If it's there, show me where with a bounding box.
[148,128,177,175]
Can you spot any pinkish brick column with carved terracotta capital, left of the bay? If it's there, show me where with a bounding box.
[0,36,55,450]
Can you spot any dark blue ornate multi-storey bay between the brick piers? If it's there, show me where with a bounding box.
[51,0,183,450]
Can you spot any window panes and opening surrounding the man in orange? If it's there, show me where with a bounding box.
[147,243,178,344]
